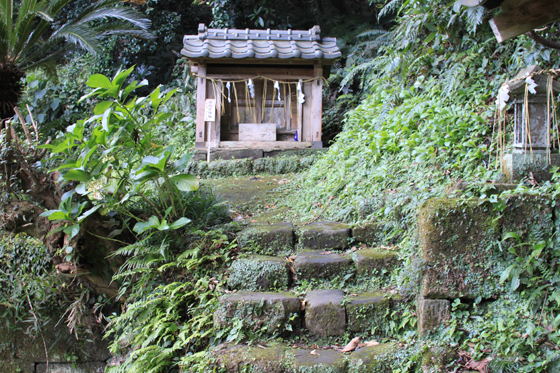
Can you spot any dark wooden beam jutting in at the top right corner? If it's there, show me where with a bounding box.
[490,0,560,43]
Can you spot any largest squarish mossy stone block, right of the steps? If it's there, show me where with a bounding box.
[418,198,501,299]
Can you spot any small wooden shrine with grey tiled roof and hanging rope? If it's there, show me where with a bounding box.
[181,24,341,149]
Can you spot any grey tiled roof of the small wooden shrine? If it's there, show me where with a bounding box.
[181,24,341,60]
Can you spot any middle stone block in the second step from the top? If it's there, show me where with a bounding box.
[294,251,353,280]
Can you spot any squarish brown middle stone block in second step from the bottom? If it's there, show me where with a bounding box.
[305,290,346,337]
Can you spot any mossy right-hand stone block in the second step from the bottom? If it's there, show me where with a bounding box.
[346,292,390,335]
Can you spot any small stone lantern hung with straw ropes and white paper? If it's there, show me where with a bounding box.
[504,66,560,182]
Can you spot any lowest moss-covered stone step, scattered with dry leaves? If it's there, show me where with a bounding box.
[209,342,398,373]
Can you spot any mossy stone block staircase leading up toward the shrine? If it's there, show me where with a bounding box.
[208,222,401,373]
